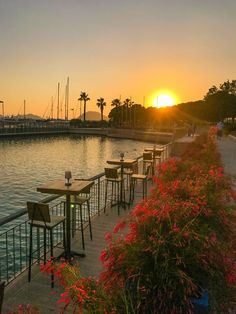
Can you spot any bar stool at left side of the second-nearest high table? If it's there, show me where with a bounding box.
[104,168,125,215]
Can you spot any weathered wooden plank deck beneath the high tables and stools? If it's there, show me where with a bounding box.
[2,184,150,314]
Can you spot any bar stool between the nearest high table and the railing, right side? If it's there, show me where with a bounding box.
[71,188,93,250]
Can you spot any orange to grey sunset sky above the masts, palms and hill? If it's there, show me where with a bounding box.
[0,0,236,116]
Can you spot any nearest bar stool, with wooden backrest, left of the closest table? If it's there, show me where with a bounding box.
[27,202,66,288]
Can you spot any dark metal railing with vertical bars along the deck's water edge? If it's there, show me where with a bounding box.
[0,143,171,284]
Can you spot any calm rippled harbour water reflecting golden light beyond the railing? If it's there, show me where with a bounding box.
[0,136,150,218]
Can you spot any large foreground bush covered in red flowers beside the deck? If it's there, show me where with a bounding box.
[39,131,236,314]
